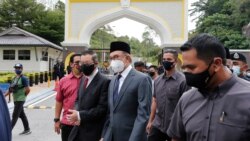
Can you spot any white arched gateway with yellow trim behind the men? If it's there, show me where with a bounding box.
[62,0,188,48]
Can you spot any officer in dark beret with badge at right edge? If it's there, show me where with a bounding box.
[231,52,250,81]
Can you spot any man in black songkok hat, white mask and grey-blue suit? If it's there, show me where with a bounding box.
[101,41,152,141]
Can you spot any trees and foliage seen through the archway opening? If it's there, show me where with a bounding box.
[90,26,161,64]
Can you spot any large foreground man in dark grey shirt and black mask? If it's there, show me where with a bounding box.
[167,34,250,141]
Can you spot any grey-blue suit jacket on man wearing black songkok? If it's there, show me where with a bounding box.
[102,69,152,141]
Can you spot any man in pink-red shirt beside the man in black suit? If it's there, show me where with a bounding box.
[54,54,82,141]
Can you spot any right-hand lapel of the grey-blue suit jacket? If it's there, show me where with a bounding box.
[114,69,135,110]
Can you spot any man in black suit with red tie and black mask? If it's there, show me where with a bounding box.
[67,50,110,141]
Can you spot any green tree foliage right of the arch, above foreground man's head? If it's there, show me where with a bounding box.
[191,0,250,49]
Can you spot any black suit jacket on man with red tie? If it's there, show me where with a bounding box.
[68,72,110,141]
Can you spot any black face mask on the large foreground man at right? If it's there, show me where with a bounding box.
[184,64,215,89]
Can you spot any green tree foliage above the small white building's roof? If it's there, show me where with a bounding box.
[0,0,65,45]
